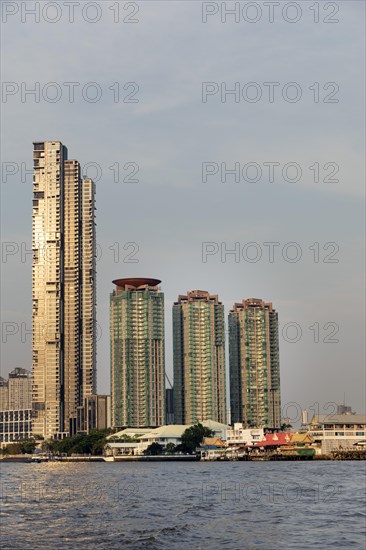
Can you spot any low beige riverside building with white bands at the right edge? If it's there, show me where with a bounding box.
[306,414,366,454]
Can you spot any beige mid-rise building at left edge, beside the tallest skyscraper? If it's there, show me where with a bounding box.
[0,367,32,443]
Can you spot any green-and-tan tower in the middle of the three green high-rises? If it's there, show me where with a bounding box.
[173,290,226,424]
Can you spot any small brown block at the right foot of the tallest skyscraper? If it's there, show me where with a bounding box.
[78,395,111,433]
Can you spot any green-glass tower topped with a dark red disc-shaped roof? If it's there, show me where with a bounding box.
[110,278,165,428]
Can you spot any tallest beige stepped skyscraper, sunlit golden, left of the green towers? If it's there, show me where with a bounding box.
[32,141,96,437]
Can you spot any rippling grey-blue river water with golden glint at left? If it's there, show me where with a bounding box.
[0,461,366,550]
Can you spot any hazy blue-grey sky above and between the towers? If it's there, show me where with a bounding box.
[1,0,366,419]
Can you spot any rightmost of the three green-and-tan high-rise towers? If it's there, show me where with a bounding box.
[229,298,281,429]
